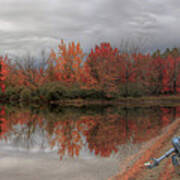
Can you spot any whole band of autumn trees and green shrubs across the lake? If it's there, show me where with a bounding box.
[0,41,180,102]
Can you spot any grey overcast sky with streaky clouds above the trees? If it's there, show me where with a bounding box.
[0,0,180,55]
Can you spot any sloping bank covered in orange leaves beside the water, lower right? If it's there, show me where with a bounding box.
[108,119,180,180]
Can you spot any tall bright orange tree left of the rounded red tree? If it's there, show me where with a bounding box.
[47,40,85,84]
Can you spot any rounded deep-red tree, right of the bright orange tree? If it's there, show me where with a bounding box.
[84,43,119,91]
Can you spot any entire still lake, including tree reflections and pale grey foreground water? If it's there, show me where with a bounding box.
[0,105,180,180]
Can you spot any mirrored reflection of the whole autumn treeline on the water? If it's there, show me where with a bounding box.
[0,106,180,159]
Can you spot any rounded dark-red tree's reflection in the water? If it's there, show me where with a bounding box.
[82,114,127,157]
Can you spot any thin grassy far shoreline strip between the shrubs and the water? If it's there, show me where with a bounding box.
[0,95,180,107]
